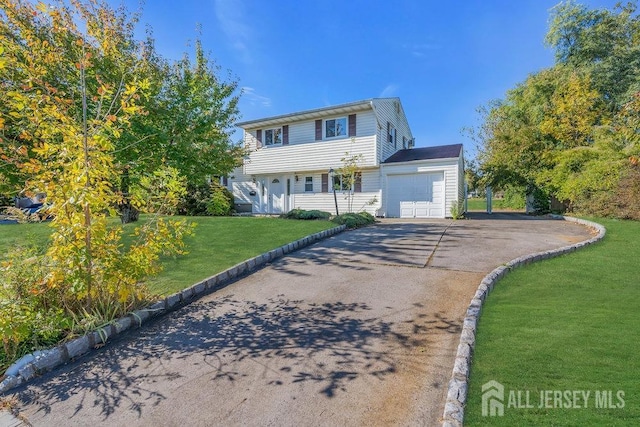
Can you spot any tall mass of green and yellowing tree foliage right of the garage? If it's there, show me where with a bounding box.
[476,1,640,217]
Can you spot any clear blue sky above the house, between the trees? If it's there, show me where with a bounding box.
[120,0,617,154]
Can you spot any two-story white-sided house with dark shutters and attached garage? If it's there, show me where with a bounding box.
[228,98,464,218]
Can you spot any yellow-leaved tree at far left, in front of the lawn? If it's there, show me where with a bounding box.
[0,0,191,362]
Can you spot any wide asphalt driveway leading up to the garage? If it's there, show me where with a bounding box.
[3,214,591,426]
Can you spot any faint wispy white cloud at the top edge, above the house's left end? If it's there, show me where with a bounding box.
[214,0,252,64]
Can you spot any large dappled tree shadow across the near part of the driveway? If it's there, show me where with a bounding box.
[16,295,460,420]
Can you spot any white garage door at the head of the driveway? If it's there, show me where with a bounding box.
[387,172,444,218]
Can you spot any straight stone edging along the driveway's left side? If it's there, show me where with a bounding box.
[0,225,346,394]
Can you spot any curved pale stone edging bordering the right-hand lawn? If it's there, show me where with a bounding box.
[442,215,606,427]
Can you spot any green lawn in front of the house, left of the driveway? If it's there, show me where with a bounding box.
[0,217,335,295]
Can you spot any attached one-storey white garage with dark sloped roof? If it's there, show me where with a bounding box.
[382,144,464,218]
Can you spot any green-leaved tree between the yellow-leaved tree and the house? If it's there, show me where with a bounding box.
[116,37,244,222]
